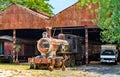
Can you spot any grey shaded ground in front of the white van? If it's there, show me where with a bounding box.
[73,62,120,77]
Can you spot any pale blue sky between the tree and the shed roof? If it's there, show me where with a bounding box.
[49,0,78,14]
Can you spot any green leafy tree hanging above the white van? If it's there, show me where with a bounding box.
[78,0,120,44]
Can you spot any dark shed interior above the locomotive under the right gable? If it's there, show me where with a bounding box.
[52,27,101,43]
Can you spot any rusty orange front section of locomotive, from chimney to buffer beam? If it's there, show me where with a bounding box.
[28,33,69,71]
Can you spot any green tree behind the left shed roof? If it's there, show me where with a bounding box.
[0,0,53,15]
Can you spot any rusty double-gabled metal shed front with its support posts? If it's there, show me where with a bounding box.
[0,3,98,64]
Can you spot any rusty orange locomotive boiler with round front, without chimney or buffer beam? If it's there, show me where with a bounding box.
[37,38,69,58]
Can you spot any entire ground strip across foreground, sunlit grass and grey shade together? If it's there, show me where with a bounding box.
[0,62,120,77]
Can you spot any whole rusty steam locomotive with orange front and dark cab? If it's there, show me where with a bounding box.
[28,33,101,70]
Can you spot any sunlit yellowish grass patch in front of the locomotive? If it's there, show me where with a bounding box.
[0,63,99,77]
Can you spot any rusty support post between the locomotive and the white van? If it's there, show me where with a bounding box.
[85,26,88,65]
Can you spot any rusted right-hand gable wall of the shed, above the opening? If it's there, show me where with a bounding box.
[51,3,98,28]
